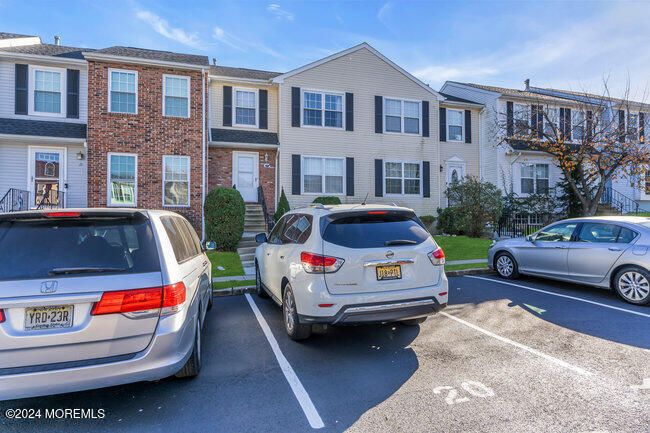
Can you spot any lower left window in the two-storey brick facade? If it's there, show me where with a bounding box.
[108,153,138,206]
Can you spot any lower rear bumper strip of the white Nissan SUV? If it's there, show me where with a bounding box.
[298,297,447,325]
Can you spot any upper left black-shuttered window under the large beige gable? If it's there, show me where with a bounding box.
[302,90,343,128]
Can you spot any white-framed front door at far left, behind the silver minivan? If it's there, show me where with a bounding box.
[27,146,66,208]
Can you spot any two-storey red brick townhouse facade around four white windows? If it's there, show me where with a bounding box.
[87,61,207,235]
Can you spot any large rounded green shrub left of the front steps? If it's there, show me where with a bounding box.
[204,187,246,251]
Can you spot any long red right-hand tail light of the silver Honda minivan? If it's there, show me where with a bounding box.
[91,282,185,316]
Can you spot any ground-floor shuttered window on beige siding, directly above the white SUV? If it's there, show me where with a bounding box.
[302,156,345,194]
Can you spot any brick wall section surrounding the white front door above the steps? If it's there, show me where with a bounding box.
[208,147,276,212]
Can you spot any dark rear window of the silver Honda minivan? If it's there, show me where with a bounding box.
[0,216,160,280]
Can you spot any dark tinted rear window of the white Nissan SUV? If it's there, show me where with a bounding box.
[323,213,429,248]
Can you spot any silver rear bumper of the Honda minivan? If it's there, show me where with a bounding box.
[0,314,194,400]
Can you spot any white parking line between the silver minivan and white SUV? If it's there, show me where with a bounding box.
[245,293,325,428]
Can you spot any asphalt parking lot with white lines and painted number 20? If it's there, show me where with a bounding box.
[0,275,650,432]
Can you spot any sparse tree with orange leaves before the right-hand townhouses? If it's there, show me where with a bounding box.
[496,81,650,215]
